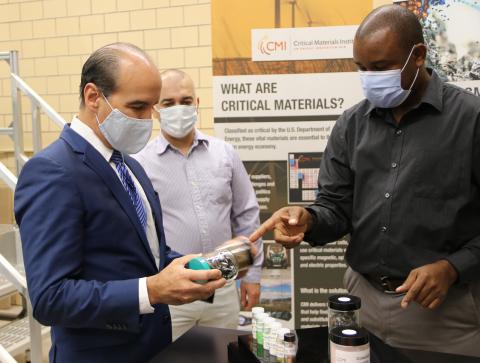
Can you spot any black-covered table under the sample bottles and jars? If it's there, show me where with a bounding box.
[150,327,480,363]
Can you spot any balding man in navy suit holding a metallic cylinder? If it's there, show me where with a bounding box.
[15,43,225,363]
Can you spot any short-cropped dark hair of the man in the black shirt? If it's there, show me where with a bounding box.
[355,5,425,52]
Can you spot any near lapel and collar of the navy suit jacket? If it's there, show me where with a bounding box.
[62,126,158,270]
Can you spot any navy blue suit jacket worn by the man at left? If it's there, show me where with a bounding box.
[15,126,179,363]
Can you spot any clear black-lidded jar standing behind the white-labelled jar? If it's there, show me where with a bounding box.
[328,294,362,332]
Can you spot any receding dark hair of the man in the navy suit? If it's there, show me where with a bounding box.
[80,42,151,107]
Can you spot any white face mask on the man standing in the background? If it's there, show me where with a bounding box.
[157,105,197,139]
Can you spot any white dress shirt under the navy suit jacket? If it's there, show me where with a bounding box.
[70,117,160,314]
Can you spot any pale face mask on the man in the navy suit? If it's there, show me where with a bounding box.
[95,94,153,154]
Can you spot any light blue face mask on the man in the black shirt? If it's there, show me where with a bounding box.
[359,46,420,108]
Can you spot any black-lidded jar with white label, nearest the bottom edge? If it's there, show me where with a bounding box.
[329,326,370,363]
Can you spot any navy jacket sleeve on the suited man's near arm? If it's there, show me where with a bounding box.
[15,156,141,332]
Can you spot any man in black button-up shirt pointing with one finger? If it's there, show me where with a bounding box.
[251,5,480,356]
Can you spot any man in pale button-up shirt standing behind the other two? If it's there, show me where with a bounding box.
[134,70,263,340]
